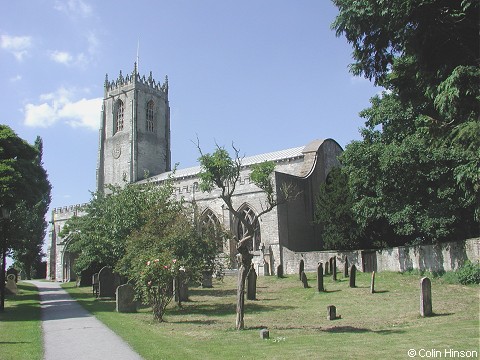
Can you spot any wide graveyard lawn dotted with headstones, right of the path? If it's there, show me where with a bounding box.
[65,272,479,359]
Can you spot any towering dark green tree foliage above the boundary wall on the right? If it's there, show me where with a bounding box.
[332,0,480,245]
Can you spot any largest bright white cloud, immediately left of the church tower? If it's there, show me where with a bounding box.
[24,87,102,131]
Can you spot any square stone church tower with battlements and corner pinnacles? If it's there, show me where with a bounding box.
[97,63,171,191]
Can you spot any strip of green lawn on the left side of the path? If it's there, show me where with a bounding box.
[0,282,43,360]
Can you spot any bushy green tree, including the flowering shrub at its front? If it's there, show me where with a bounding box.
[117,198,217,321]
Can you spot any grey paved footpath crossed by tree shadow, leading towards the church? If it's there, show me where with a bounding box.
[31,281,142,360]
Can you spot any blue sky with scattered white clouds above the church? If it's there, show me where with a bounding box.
[0,0,379,214]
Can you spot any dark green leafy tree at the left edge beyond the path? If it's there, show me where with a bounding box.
[0,125,51,308]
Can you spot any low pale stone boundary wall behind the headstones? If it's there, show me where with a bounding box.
[282,238,480,274]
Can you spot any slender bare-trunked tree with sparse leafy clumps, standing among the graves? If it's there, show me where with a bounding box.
[197,143,294,330]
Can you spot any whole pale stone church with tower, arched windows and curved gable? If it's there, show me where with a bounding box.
[47,64,342,281]
